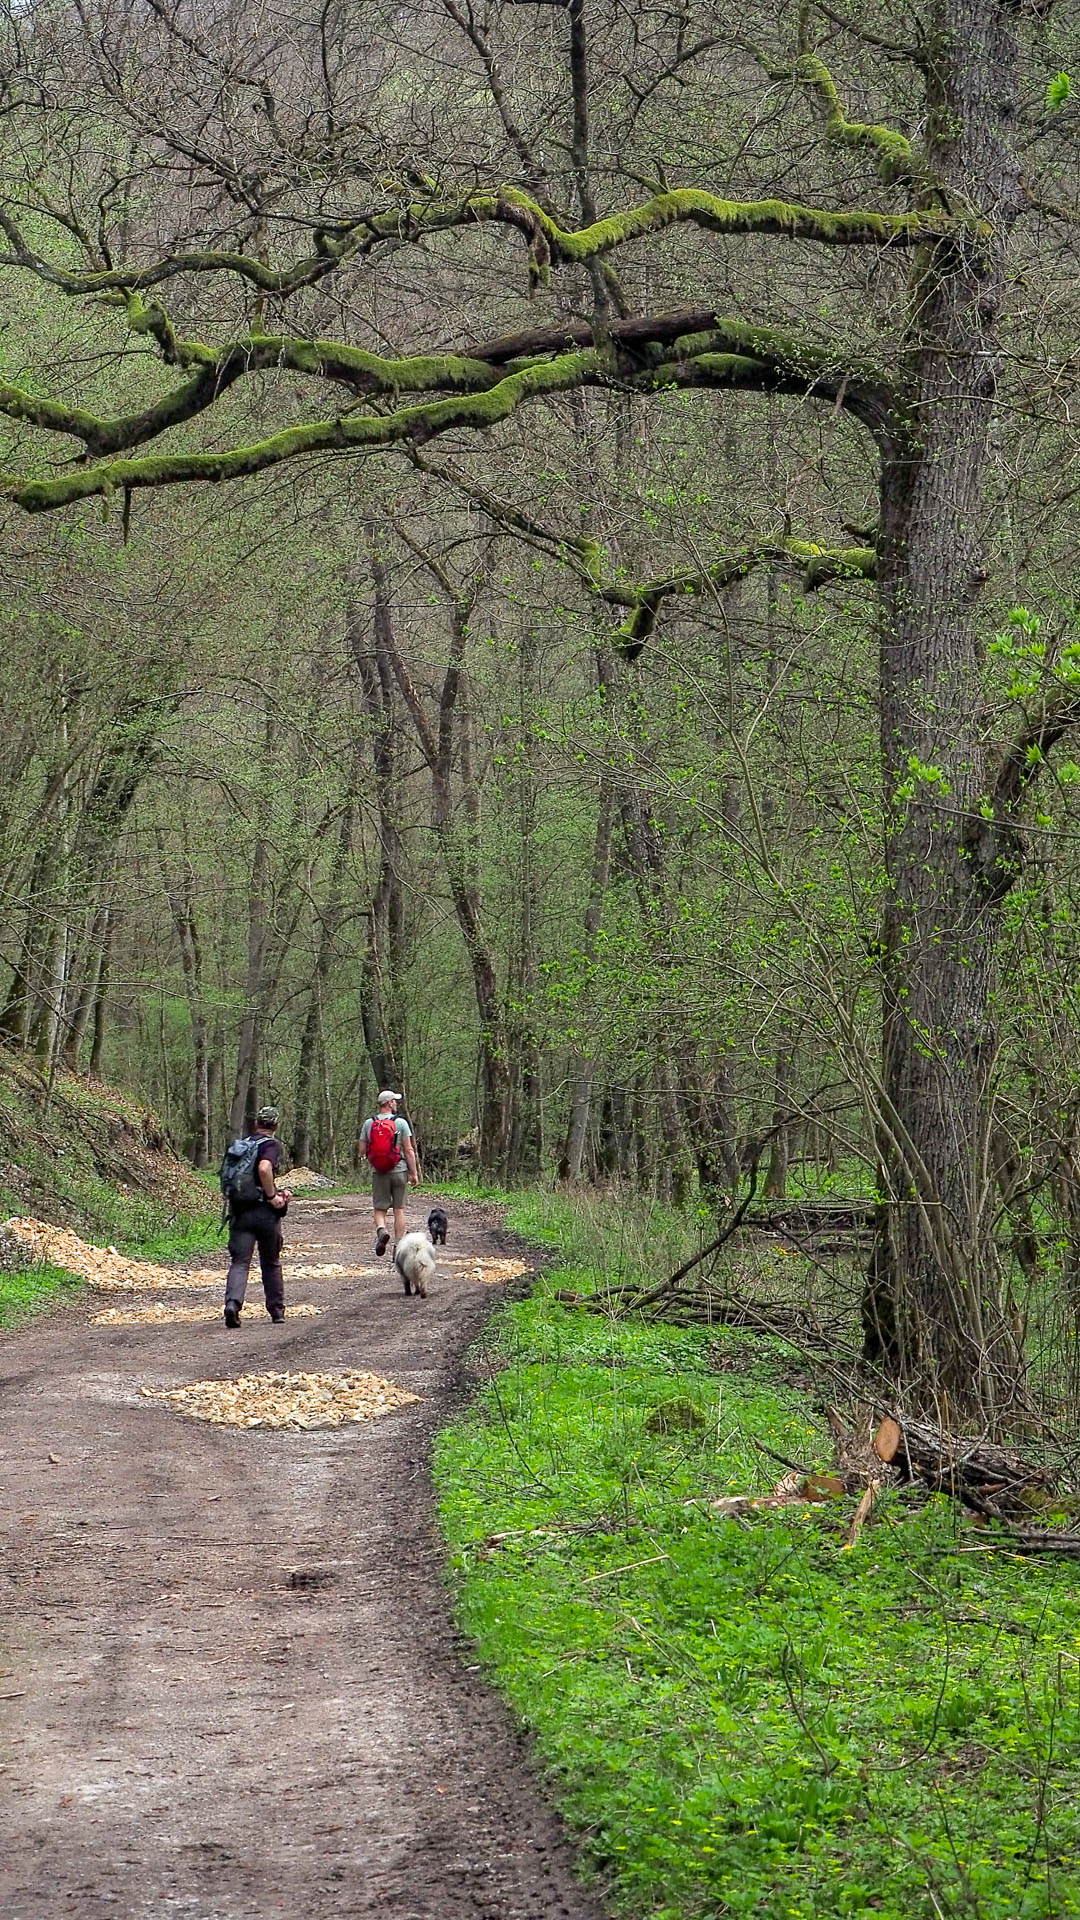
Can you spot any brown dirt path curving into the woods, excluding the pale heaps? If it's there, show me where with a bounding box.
[0,1198,598,1920]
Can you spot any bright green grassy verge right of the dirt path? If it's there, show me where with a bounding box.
[436,1194,1080,1920]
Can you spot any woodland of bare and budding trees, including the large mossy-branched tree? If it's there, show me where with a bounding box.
[0,0,1080,1427]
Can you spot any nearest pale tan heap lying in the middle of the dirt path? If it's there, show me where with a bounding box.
[138,1373,419,1430]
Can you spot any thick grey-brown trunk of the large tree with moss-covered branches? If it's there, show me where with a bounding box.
[865,0,1019,1415]
